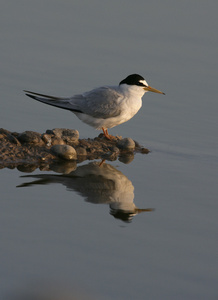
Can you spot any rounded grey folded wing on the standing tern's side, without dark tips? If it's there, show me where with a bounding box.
[76,87,123,119]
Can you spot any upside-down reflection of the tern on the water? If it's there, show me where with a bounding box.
[18,162,153,222]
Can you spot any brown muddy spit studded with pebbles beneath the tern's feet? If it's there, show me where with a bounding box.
[0,128,149,168]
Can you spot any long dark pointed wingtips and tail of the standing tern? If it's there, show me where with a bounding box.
[24,91,83,113]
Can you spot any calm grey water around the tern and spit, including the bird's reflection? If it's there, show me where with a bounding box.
[0,0,218,299]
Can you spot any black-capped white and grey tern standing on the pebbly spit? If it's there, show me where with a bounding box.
[24,74,164,139]
